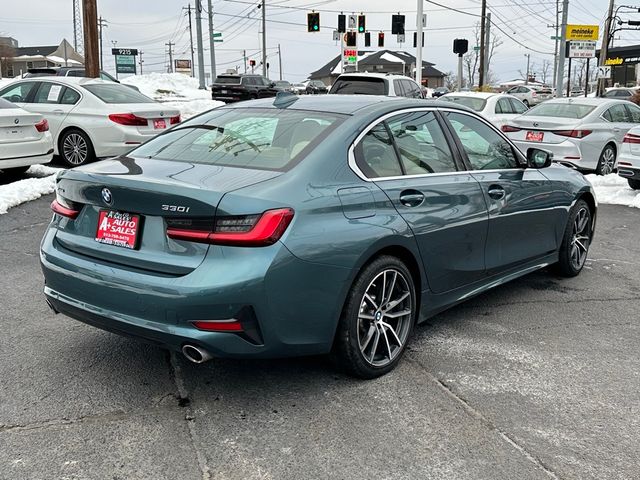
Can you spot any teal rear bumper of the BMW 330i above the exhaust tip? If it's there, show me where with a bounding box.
[40,228,350,358]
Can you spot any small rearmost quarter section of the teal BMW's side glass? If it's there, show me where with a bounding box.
[355,123,402,178]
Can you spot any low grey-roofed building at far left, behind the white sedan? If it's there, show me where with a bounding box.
[0,37,84,77]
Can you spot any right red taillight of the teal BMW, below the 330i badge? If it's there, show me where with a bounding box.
[167,208,294,247]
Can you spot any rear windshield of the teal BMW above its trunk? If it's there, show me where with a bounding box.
[130,108,345,171]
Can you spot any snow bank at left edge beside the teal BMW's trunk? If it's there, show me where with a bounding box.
[0,165,60,215]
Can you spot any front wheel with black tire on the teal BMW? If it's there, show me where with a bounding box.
[556,200,593,277]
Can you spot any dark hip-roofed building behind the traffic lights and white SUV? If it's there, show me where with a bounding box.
[309,50,446,88]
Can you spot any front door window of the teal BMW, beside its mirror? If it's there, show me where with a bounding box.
[446,112,519,170]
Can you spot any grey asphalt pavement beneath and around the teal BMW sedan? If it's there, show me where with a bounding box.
[0,196,640,480]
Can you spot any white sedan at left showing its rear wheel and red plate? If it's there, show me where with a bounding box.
[0,77,180,167]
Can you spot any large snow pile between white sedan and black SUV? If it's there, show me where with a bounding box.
[122,73,224,120]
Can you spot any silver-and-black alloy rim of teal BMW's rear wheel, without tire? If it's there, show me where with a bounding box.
[358,269,413,367]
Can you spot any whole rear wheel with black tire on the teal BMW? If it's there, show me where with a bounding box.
[331,255,417,379]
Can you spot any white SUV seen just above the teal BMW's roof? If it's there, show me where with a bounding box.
[329,73,423,98]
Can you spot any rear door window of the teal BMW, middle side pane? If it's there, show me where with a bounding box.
[389,112,457,175]
